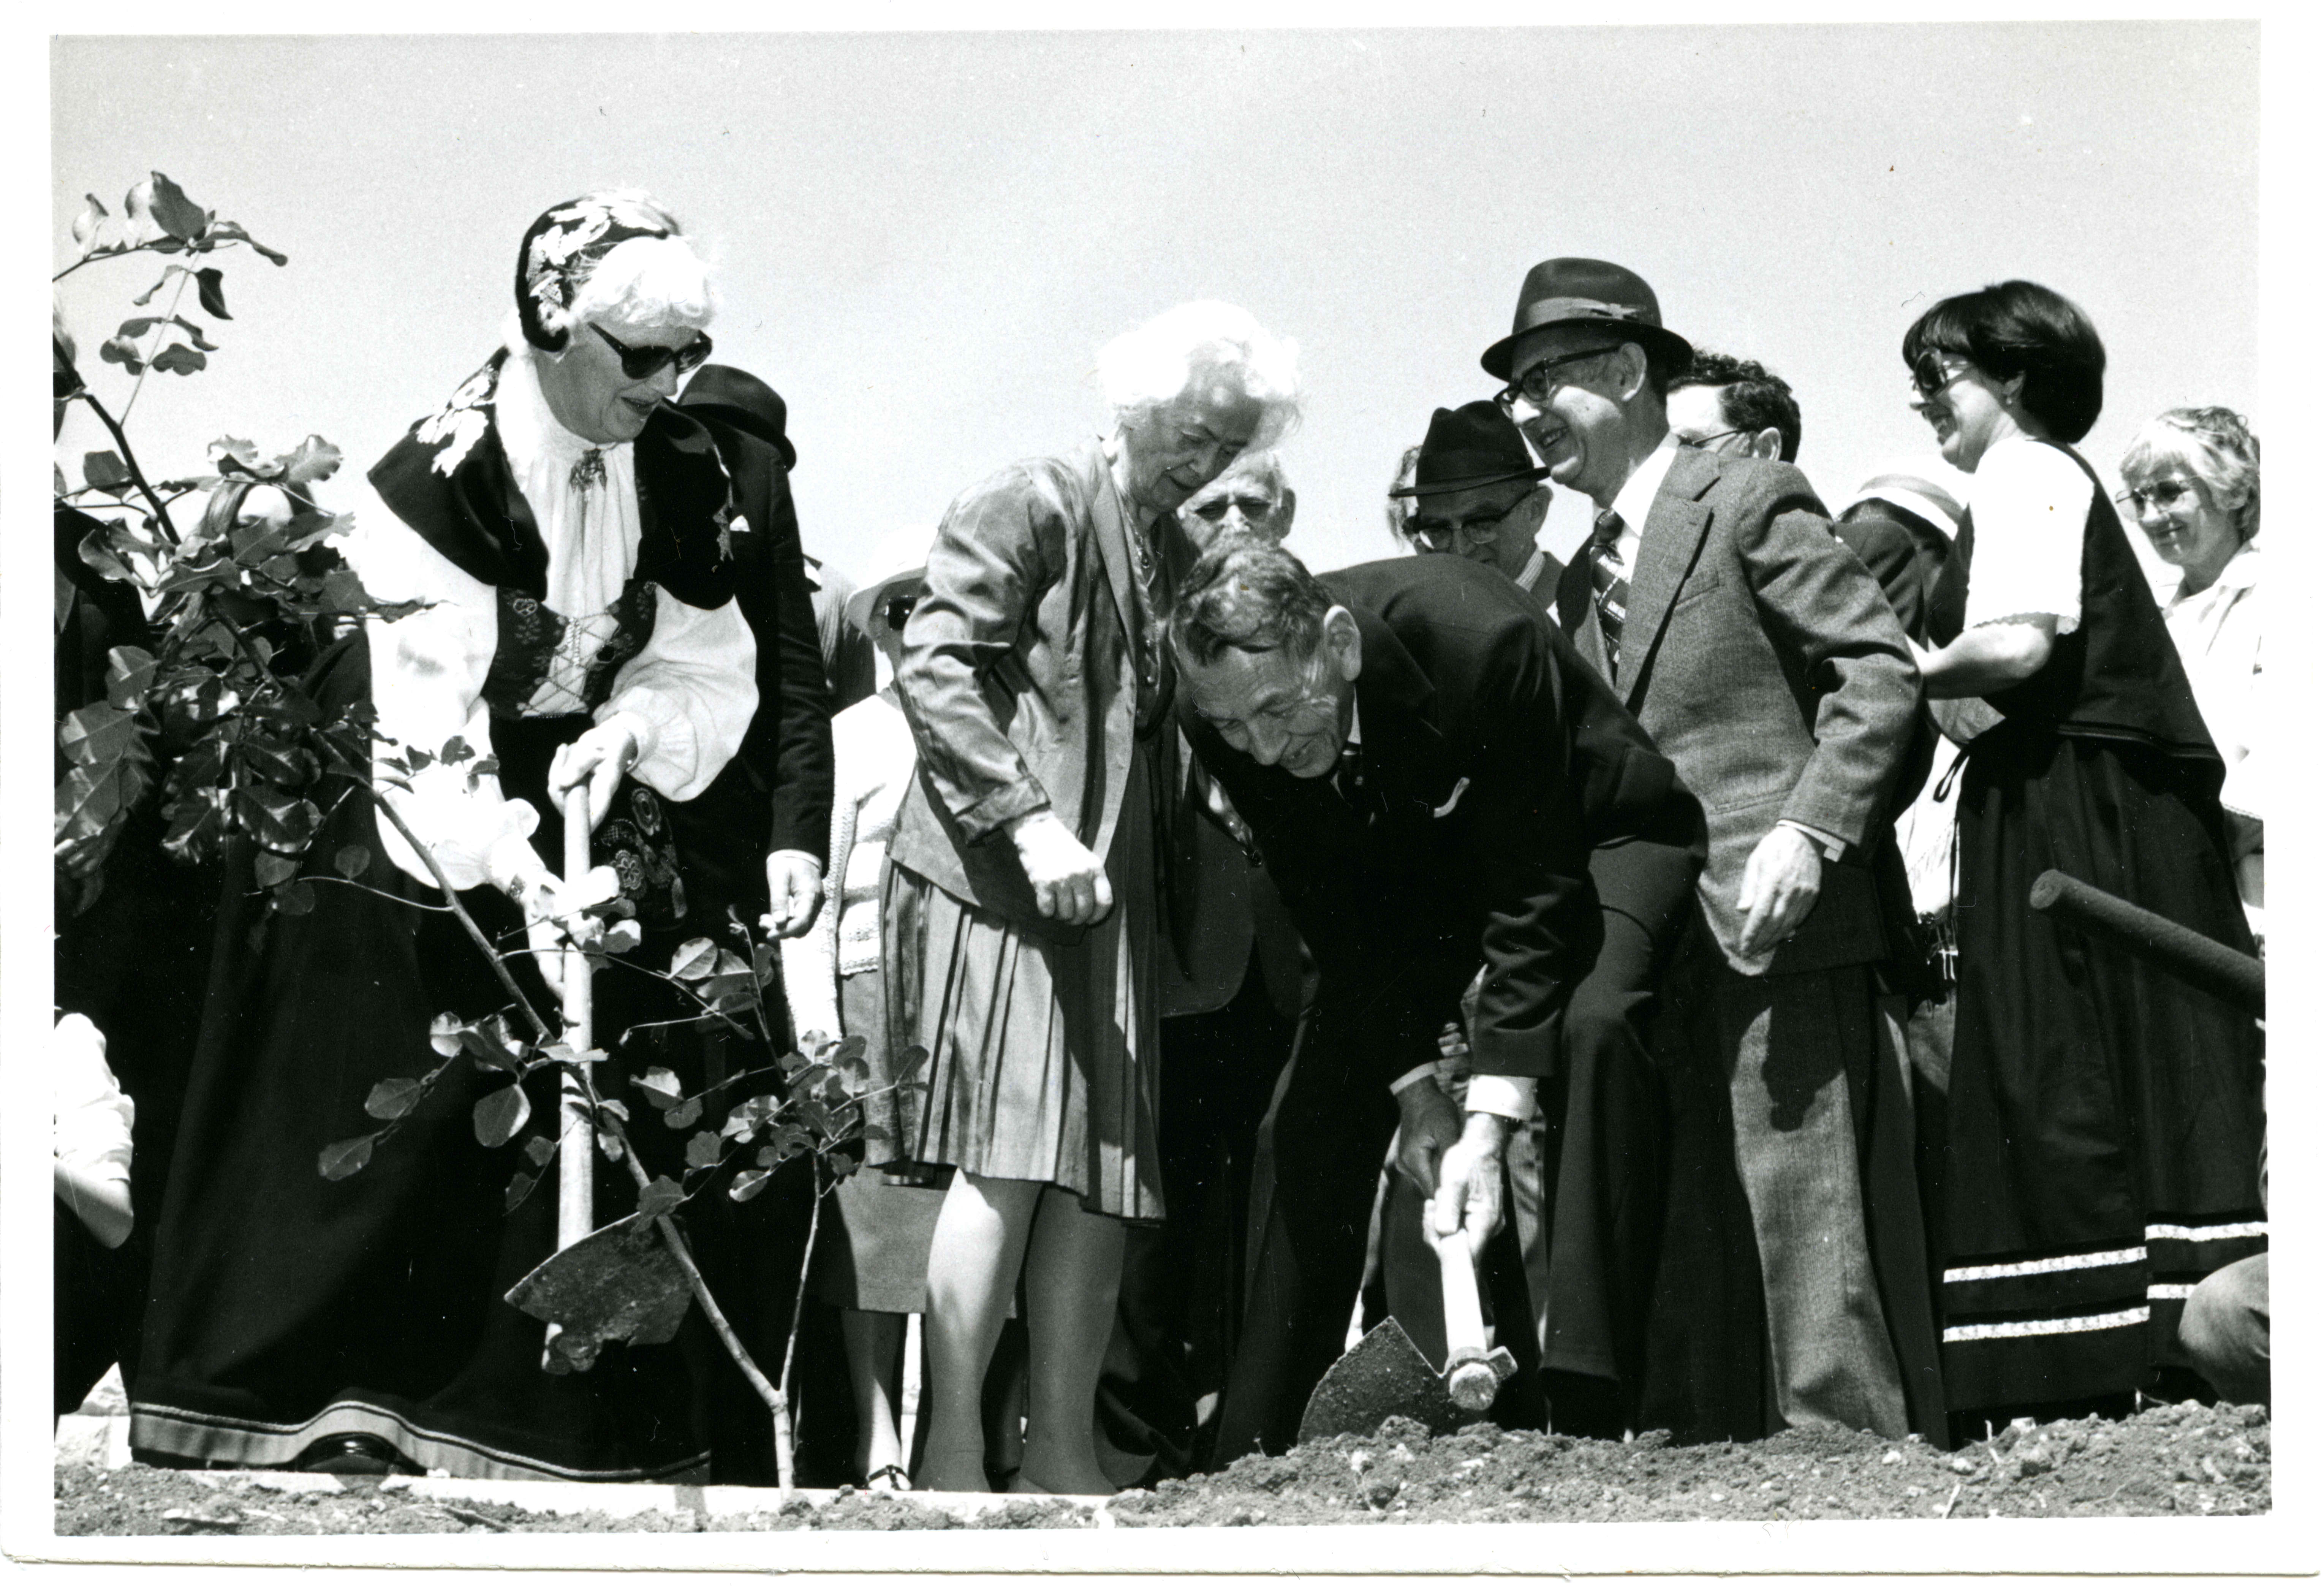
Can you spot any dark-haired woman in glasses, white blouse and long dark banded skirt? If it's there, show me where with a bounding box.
[1903,281,2266,1426]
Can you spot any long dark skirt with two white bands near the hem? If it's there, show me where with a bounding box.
[1941,727,2266,1409]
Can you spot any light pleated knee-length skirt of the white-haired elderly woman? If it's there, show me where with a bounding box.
[881,741,1162,1221]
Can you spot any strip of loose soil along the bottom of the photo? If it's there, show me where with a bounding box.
[56,1403,2270,1537]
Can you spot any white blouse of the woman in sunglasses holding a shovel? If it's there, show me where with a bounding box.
[346,348,758,889]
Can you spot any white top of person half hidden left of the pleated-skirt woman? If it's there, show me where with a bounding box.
[783,694,920,1036]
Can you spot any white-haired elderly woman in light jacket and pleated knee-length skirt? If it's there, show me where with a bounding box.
[883,302,1297,1493]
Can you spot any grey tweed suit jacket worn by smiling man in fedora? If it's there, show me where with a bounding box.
[1557,446,1920,973]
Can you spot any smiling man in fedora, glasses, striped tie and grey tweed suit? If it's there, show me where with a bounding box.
[1432,258,1943,1437]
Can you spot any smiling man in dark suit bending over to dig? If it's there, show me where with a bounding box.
[1171,539,1675,1463]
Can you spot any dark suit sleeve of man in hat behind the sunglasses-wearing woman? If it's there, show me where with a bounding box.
[751,462,832,859]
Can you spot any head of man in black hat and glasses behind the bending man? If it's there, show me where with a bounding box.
[1387,402,1566,606]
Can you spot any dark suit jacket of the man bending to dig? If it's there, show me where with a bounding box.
[1180,557,1675,1085]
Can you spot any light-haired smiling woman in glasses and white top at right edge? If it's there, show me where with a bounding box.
[2122,406,2266,936]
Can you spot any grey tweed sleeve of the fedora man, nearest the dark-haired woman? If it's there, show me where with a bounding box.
[1734,465,1920,848]
